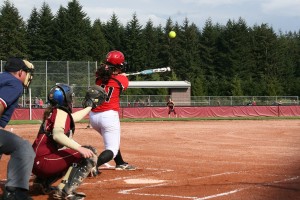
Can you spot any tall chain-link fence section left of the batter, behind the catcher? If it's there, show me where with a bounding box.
[1,61,97,107]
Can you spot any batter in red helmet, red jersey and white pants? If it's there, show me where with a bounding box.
[90,51,136,173]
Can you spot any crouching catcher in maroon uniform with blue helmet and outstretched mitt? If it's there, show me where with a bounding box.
[32,84,106,200]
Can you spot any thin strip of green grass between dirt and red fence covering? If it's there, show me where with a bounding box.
[9,116,300,125]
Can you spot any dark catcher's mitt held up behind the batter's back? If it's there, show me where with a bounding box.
[82,85,107,108]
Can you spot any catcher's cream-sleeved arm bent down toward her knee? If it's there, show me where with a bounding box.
[52,109,81,151]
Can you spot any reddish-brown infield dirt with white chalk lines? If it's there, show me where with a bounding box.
[0,120,300,200]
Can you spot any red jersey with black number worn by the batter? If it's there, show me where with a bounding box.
[92,74,129,112]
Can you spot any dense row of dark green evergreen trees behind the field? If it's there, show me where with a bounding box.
[0,0,300,96]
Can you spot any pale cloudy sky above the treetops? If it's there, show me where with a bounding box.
[5,0,300,32]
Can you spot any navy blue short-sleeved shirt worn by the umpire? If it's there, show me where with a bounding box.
[0,72,23,128]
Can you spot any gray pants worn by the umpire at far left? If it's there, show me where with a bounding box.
[0,129,35,190]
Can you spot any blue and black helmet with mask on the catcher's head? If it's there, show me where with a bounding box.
[48,83,74,112]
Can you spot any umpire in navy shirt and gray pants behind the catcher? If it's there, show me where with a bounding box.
[0,58,35,200]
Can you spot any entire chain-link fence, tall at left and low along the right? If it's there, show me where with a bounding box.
[0,61,299,107]
